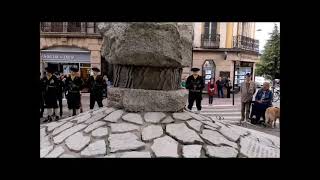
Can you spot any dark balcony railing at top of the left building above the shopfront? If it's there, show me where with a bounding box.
[40,22,100,37]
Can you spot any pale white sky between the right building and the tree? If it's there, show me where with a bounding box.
[255,22,280,53]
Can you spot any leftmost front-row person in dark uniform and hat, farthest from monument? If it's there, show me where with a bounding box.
[42,67,59,122]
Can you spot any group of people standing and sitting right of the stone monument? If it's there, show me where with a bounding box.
[185,68,273,124]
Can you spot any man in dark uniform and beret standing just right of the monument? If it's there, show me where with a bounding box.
[186,68,204,113]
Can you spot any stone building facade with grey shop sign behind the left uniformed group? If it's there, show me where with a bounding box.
[40,22,112,80]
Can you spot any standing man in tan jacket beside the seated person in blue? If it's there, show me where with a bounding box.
[240,73,256,124]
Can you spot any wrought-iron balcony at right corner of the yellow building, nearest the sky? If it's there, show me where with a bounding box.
[233,35,259,52]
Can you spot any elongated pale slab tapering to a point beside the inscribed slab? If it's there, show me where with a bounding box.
[200,129,238,148]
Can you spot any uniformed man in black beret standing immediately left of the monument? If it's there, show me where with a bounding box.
[87,67,106,109]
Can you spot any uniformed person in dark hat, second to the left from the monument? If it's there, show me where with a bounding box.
[65,66,83,116]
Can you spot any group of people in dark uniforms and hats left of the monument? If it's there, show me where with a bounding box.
[40,66,107,122]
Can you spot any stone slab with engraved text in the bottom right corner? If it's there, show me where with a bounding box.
[240,137,280,158]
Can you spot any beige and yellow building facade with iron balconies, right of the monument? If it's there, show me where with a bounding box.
[188,22,259,92]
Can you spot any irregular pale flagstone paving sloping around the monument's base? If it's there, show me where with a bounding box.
[40,107,280,158]
